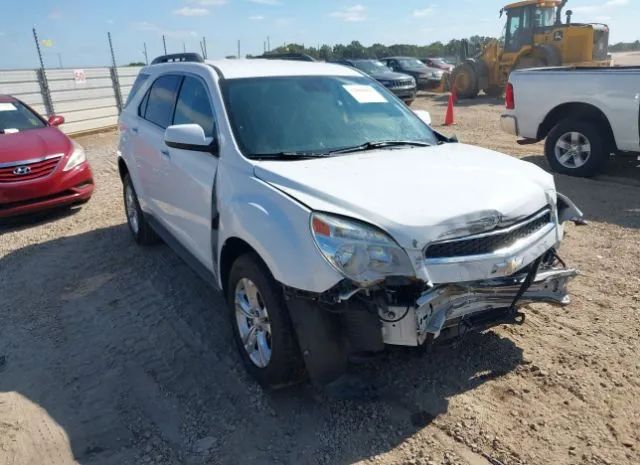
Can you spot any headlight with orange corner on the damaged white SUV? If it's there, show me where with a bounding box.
[311,213,415,285]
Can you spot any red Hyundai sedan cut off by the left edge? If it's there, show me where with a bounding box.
[0,95,94,218]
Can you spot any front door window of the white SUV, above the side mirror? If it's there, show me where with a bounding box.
[173,76,215,137]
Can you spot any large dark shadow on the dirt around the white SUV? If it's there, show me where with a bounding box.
[0,225,522,465]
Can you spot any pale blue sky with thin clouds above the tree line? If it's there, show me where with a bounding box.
[0,0,640,69]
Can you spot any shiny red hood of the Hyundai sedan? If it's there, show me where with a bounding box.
[0,127,72,163]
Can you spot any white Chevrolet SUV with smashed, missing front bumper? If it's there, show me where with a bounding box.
[118,55,582,396]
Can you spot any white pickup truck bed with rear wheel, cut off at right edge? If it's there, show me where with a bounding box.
[501,67,640,177]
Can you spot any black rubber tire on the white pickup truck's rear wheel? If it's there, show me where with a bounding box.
[545,119,609,178]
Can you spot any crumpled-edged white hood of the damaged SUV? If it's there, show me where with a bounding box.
[254,144,555,248]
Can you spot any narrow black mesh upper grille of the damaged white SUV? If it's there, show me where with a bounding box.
[425,209,552,259]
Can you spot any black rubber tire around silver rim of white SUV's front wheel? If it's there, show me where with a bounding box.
[227,253,305,389]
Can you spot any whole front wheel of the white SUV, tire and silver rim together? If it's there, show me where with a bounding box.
[227,254,304,388]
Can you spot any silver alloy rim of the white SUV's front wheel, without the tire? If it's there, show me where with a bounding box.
[235,278,271,368]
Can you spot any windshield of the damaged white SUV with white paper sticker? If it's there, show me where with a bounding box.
[223,76,438,158]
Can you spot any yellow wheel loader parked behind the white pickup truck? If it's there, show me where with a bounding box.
[450,0,611,98]
